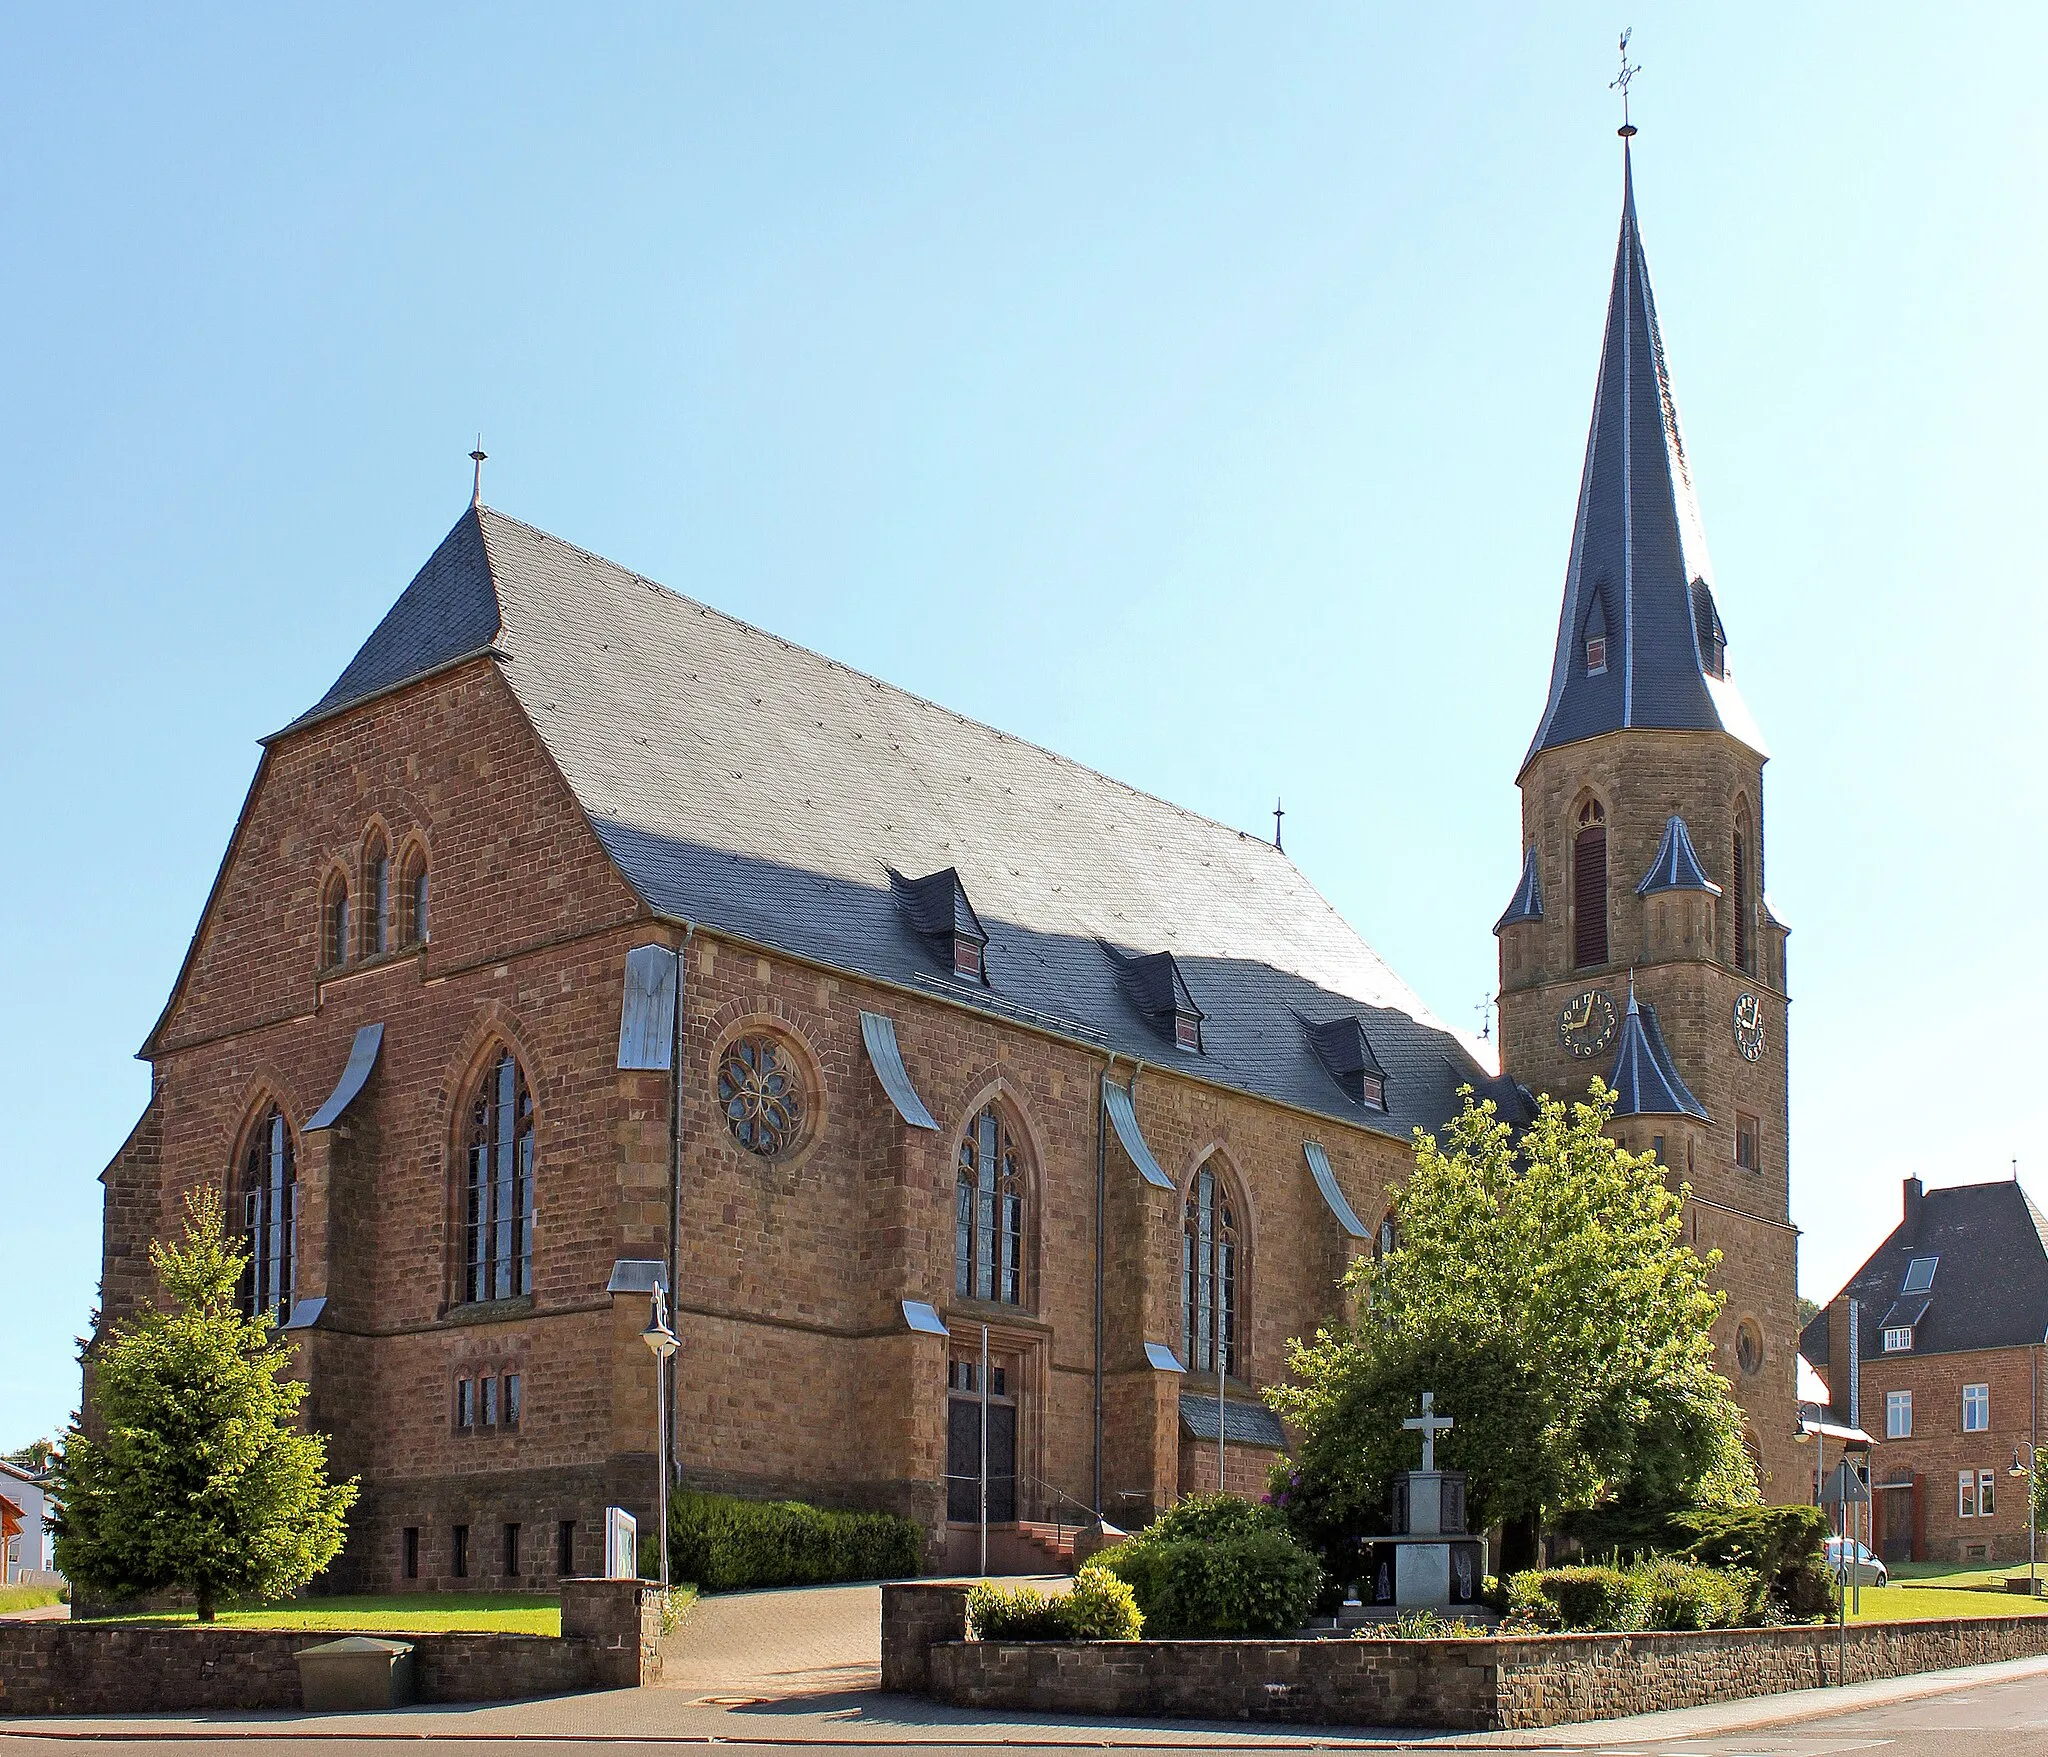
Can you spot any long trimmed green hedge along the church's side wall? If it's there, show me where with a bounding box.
[659,1491,924,1593]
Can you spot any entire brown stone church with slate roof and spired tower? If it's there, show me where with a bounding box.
[102,143,1794,1589]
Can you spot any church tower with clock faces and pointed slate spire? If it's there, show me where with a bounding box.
[1495,143,1804,1501]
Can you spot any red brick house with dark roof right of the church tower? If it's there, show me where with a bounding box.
[1800,1177,2048,1562]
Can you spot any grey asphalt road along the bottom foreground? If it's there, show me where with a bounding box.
[12,1669,2048,1757]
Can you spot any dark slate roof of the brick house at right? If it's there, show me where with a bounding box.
[1800,1180,2048,1366]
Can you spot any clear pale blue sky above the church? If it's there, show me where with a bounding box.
[0,0,2048,1446]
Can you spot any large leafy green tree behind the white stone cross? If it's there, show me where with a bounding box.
[1268,1081,1755,1569]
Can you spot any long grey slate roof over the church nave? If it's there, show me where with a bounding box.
[276,508,1491,1139]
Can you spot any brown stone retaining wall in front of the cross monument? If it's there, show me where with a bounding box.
[883,1585,2048,1730]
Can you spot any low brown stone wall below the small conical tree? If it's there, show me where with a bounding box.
[0,1581,662,1716]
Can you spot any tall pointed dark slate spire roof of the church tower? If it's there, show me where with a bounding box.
[1524,147,1763,768]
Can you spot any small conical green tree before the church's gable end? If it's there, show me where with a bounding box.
[53,1190,356,1622]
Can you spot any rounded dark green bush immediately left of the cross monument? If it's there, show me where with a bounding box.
[1102,1495,1323,1638]
